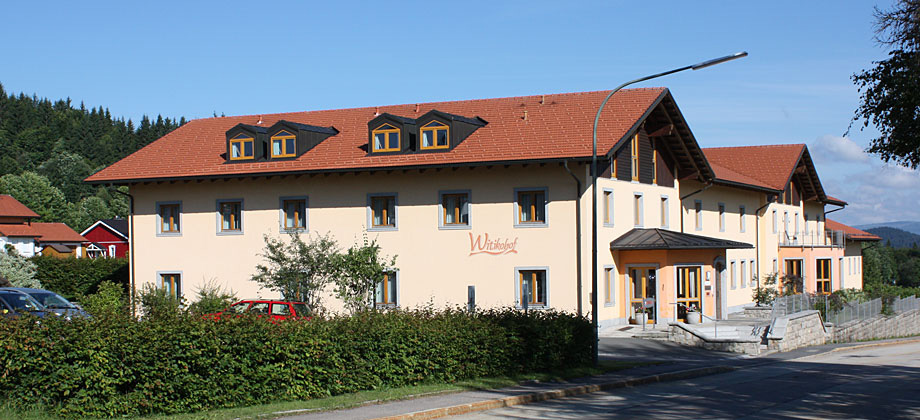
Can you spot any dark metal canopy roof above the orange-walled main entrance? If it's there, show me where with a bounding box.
[610,228,754,251]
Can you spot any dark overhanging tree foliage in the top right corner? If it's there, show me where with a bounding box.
[848,0,920,168]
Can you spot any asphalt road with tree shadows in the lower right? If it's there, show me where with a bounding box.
[454,342,920,419]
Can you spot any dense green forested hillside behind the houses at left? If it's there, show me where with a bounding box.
[0,84,186,232]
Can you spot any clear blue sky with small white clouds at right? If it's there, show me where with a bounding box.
[0,1,920,224]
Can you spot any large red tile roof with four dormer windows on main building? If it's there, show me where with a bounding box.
[86,88,669,182]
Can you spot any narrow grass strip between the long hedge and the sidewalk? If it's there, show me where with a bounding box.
[7,361,655,420]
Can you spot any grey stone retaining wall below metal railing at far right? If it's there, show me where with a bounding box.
[828,309,920,343]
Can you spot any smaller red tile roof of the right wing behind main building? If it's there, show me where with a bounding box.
[703,144,805,191]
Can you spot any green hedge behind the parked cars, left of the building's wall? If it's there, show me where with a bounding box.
[30,256,129,299]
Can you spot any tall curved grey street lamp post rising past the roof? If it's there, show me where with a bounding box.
[591,51,747,365]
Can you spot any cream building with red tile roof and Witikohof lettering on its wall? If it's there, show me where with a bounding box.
[88,88,876,325]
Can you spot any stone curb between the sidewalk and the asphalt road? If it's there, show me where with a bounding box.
[376,366,738,420]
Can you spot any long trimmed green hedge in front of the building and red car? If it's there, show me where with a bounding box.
[0,310,593,418]
